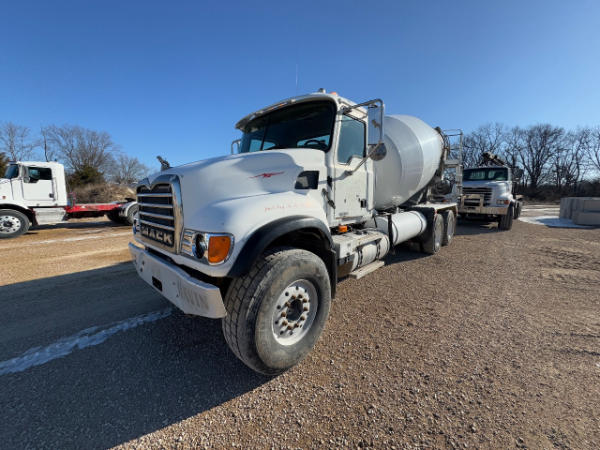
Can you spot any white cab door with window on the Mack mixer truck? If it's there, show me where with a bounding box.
[333,115,371,224]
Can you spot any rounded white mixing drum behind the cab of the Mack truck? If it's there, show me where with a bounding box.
[374,115,444,209]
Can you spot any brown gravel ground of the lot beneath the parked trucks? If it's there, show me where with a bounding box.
[0,214,600,449]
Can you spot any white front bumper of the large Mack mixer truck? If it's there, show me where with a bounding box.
[129,244,227,319]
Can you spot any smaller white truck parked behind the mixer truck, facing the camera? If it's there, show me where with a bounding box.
[458,152,523,230]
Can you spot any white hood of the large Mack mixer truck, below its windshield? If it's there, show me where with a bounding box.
[142,148,327,231]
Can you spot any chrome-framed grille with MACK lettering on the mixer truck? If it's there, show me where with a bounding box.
[137,177,181,252]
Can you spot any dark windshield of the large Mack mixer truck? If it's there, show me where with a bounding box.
[240,101,335,153]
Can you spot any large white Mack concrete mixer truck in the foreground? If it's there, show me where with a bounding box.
[130,90,458,374]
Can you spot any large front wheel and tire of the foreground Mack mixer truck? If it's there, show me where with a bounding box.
[222,248,331,375]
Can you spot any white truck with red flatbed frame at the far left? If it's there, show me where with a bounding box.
[0,161,137,239]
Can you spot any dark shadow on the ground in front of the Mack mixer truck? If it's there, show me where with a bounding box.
[0,264,270,448]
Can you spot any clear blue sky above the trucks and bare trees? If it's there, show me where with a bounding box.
[0,0,600,167]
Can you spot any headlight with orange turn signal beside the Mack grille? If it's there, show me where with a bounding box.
[181,229,233,265]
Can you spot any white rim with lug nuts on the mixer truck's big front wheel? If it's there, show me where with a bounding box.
[271,279,319,346]
